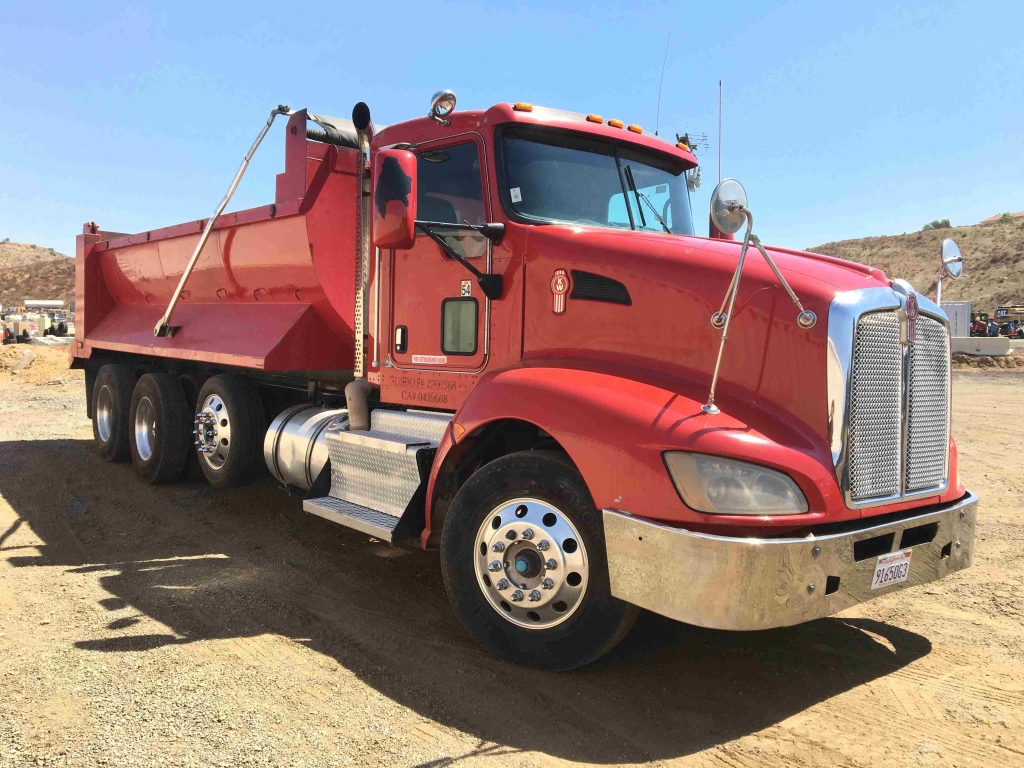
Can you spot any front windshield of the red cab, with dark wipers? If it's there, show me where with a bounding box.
[501,126,693,234]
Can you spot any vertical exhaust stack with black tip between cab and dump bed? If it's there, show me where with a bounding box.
[345,101,374,431]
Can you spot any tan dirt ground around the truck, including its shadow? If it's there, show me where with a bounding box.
[0,347,1024,768]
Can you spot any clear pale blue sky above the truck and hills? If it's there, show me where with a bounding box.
[0,0,1024,259]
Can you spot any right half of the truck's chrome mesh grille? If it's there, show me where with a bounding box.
[904,316,949,494]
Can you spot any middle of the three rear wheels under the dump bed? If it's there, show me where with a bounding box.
[128,373,191,485]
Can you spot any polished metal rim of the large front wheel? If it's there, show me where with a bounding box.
[473,498,590,630]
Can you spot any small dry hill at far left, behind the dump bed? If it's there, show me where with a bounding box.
[0,242,75,307]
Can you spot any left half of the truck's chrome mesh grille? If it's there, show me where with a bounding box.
[849,311,903,502]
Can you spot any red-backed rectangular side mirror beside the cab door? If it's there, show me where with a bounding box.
[374,150,417,251]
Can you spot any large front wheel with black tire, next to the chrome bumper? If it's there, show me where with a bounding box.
[441,451,640,670]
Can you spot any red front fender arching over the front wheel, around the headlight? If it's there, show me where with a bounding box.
[423,360,964,543]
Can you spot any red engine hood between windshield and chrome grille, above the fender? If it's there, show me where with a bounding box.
[523,225,890,453]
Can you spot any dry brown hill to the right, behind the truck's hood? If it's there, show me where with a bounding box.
[807,218,1024,312]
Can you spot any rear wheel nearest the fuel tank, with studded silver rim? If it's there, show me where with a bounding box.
[196,374,266,488]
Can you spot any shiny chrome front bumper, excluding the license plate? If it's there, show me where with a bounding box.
[604,493,978,630]
